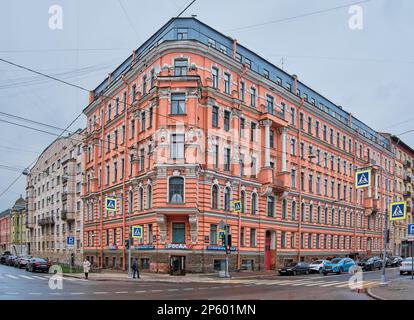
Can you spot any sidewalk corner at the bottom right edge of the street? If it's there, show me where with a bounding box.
[368,277,414,300]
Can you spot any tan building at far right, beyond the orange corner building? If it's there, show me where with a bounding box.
[386,134,414,257]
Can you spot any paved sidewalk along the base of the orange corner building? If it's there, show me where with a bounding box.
[63,271,276,283]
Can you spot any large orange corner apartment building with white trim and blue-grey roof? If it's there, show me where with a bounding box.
[83,18,394,272]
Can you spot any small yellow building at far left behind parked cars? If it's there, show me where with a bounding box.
[11,196,28,255]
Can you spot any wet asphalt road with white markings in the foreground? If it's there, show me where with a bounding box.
[0,265,406,300]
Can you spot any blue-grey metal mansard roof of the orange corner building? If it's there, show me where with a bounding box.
[88,17,402,151]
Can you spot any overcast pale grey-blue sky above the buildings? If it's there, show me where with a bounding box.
[0,0,414,210]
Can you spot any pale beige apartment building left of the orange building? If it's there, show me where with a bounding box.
[26,130,83,265]
